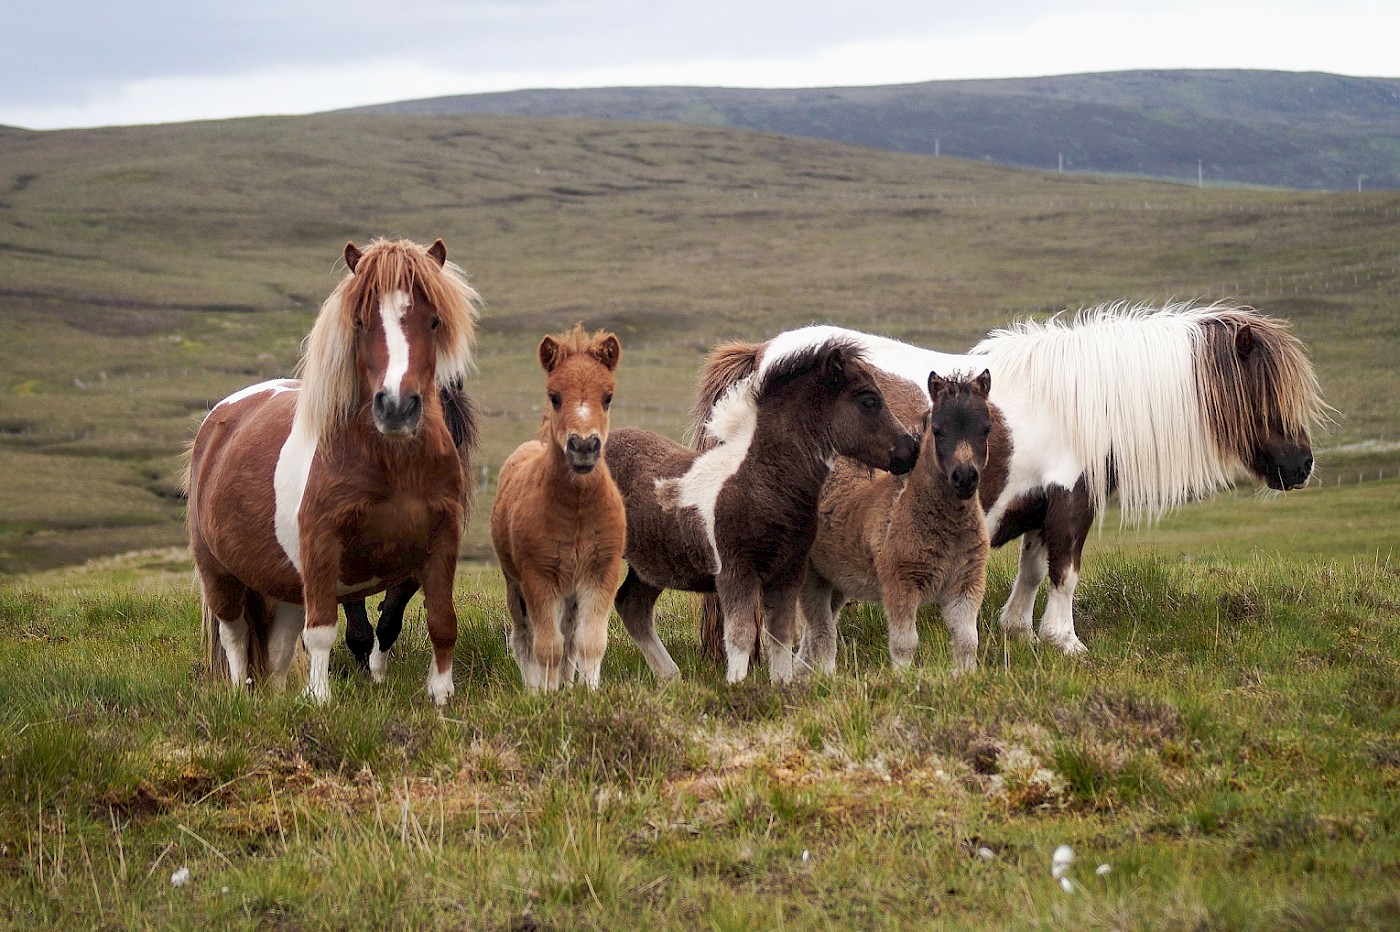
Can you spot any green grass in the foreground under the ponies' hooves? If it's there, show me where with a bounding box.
[0,481,1400,929]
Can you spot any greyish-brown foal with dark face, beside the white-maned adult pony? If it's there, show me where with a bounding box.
[798,371,1002,673]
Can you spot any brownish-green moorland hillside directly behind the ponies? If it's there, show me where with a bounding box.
[0,116,1400,571]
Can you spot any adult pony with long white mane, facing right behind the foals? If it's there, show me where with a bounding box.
[699,304,1329,654]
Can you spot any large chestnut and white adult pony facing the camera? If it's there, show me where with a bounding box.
[186,239,477,705]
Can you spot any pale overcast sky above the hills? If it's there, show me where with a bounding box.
[0,0,1400,129]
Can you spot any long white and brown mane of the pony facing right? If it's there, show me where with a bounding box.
[972,302,1327,522]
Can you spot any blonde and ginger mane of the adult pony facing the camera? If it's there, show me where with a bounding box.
[294,238,480,437]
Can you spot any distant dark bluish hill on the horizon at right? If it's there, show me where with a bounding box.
[347,70,1400,190]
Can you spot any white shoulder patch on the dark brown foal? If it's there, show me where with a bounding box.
[657,376,759,575]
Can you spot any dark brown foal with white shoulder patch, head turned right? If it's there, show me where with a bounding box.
[606,340,917,683]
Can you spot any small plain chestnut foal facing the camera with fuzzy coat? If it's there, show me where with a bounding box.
[491,326,627,690]
